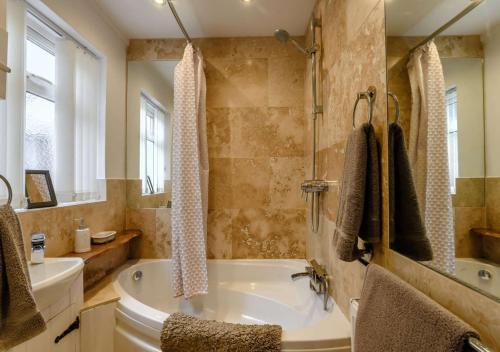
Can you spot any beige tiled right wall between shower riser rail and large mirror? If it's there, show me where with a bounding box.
[305,0,387,315]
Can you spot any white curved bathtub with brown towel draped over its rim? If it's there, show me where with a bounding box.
[113,260,351,352]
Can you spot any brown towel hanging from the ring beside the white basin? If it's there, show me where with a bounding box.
[0,205,46,351]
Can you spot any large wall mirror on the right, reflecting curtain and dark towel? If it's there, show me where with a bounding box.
[386,0,500,301]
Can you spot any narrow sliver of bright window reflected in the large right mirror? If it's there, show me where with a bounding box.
[446,87,458,194]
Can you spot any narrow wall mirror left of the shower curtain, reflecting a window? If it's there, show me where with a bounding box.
[127,60,178,208]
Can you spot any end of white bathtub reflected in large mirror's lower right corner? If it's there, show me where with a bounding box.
[455,258,500,297]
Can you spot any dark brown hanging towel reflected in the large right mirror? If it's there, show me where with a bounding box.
[389,123,432,260]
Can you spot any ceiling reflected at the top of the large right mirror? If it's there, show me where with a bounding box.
[386,0,500,36]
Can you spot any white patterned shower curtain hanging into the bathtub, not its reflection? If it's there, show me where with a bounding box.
[172,44,208,298]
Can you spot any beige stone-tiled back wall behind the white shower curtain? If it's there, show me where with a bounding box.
[128,37,306,258]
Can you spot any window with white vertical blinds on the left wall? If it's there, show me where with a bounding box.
[0,1,106,208]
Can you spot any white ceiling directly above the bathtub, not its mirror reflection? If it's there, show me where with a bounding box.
[95,0,315,39]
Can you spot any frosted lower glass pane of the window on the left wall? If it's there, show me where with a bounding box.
[24,93,55,174]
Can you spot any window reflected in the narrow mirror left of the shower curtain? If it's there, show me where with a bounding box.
[141,94,166,193]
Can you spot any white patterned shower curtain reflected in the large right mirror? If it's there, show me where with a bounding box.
[408,42,455,273]
